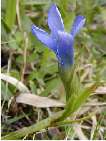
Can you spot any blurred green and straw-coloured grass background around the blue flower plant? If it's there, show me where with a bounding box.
[1,0,106,139]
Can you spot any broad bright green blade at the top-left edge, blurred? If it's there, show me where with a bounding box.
[5,0,16,30]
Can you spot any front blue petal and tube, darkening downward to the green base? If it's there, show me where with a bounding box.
[57,31,74,68]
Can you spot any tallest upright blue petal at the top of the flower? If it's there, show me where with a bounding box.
[48,4,64,34]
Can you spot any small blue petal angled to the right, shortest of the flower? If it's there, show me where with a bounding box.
[71,15,85,37]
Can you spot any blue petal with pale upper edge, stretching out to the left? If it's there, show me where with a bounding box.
[32,25,56,51]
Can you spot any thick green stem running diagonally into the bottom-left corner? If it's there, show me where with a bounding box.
[1,110,64,140]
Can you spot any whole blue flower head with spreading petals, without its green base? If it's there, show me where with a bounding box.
[32,4,85,68]
